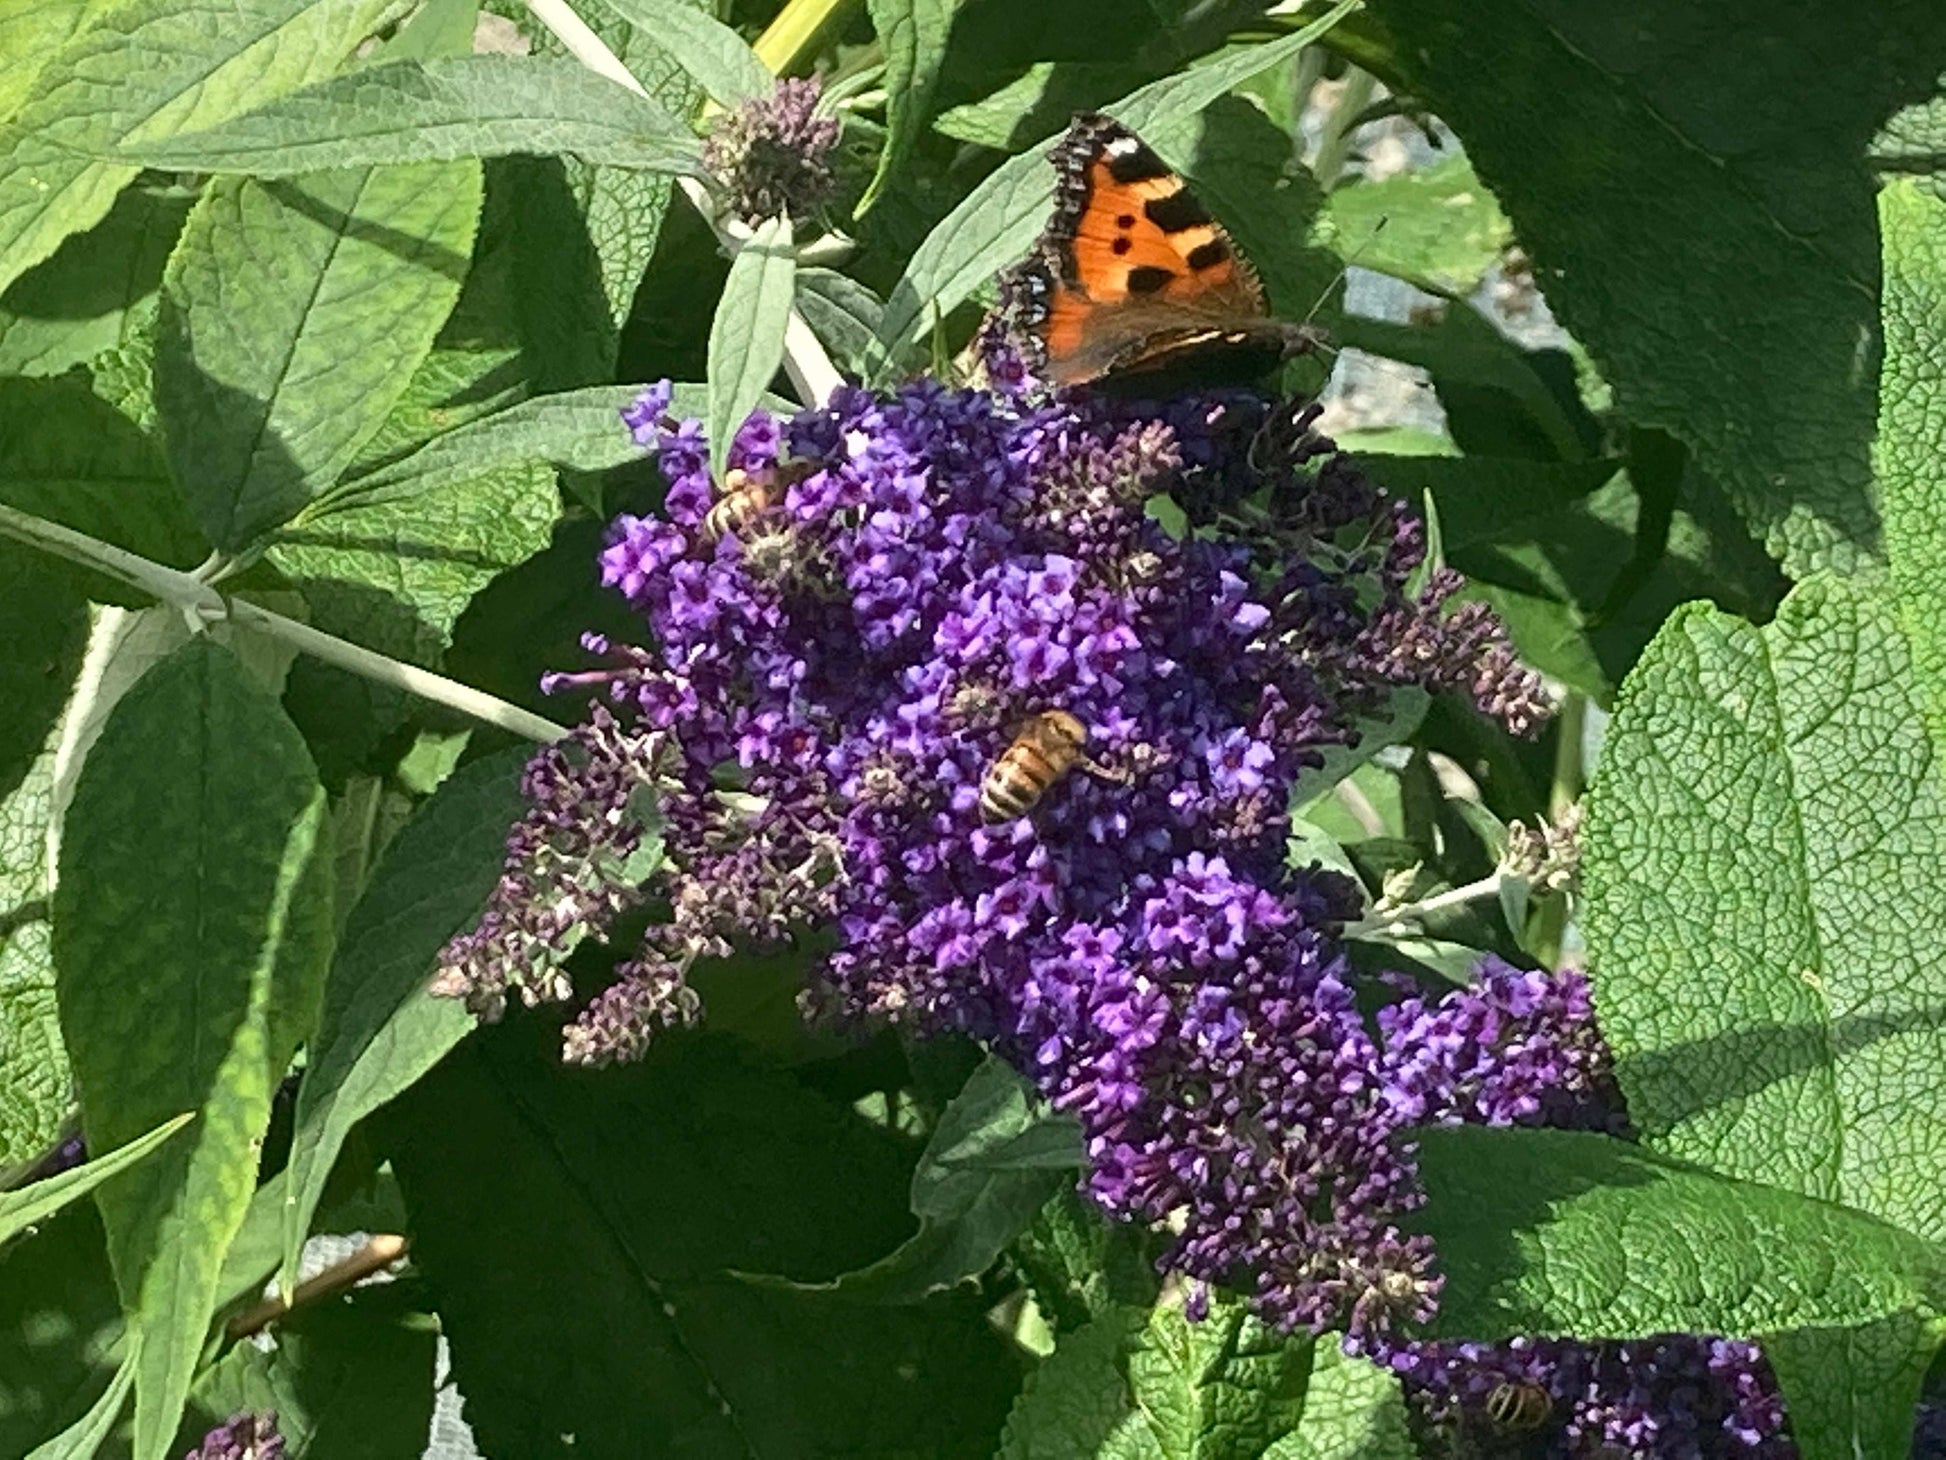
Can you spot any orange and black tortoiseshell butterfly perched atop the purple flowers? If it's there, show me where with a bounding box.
[994,113,1319,395]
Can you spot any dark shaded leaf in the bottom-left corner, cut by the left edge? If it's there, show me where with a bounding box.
[0,1201,126,1454]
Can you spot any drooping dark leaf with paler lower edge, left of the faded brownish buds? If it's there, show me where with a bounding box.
[282,746,529,1291]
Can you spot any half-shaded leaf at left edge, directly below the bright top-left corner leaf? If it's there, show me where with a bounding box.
[0,187,193,376]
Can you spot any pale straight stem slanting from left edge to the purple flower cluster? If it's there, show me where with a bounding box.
[0,504,568,744]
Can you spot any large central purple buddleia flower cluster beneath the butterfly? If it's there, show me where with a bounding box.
[442,364,1537,1333]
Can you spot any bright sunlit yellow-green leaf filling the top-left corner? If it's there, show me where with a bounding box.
[0,0,385,290]
